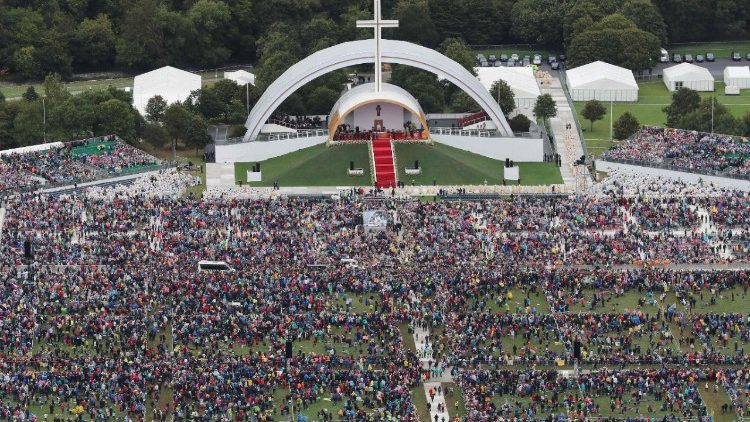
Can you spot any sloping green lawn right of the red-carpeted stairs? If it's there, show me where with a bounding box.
[396,143,562,185]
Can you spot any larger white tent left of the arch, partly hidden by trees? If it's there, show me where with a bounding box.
[133,66,201,115]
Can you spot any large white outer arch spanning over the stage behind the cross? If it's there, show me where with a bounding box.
[245,40,513,141]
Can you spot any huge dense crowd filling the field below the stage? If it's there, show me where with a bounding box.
[0,157,750,421]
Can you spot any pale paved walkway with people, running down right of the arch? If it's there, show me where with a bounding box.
[539,78,590,187]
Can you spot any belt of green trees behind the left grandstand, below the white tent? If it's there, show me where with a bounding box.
[0,74,259,150]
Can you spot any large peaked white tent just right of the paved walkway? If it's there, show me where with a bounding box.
[565,61,638,101]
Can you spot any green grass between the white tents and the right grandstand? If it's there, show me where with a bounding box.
[575,81,750,156]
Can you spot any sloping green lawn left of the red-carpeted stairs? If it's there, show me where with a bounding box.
[234,144,371,186]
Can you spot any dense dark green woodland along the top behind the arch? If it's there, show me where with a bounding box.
[0,0,750,84]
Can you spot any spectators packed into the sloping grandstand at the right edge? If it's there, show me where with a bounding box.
[602,127,750,176]
